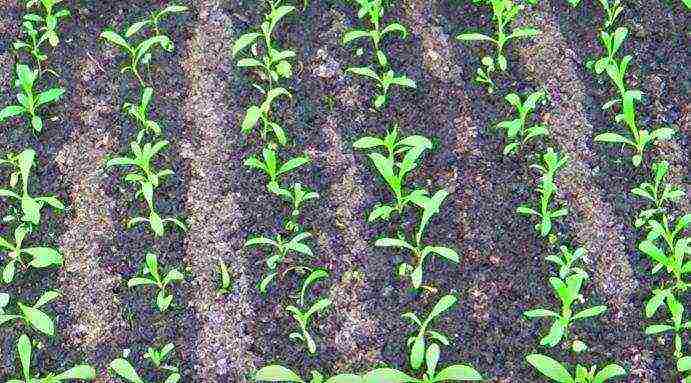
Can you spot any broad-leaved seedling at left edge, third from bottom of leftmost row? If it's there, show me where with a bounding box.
[0,225,62,283]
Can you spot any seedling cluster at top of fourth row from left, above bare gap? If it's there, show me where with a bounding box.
[342,0,416,109]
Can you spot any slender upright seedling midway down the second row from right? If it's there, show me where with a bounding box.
[516,148,569,237]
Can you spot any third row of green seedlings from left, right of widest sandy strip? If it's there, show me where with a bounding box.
[232,0,331,355]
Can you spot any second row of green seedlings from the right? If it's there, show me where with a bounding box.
[457,0,626,383]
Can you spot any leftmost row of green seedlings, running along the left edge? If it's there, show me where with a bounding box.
[0,0,96,382]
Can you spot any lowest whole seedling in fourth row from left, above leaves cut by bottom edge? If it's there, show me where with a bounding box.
[402,295,457,370]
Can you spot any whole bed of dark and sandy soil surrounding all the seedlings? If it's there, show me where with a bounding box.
[0,0,690,383]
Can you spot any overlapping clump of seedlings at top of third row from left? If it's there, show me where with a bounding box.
[232,0,295,145]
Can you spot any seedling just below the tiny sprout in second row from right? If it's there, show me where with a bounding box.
[497,90,548,155]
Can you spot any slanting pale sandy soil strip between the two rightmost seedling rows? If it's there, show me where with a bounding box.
[519,10,638,317]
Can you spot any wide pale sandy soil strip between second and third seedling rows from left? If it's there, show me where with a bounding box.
[181,0,256,382]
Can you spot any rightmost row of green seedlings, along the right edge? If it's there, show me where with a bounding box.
[587,0,691,381]
